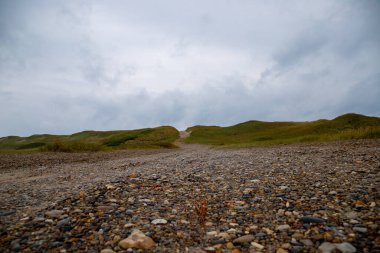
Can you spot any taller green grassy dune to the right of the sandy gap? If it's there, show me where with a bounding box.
[185,113,380,147]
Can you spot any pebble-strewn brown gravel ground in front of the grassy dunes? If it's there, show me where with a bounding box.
[0,140,380,253]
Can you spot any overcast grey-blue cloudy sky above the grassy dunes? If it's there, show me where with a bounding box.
[0,0,380,136]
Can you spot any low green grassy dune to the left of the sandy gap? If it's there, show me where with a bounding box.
[0,126,179,152]
